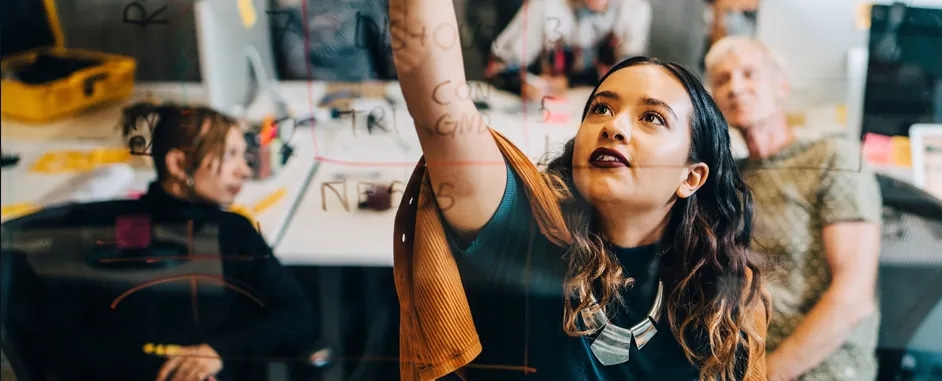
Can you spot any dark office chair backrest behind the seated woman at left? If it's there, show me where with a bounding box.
[0,201,225,380]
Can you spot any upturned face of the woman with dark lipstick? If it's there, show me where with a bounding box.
[572,64,705,211]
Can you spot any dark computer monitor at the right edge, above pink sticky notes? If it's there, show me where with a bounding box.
[861,0,942,137]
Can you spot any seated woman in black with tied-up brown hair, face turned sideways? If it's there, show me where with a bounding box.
[47,102,317,381]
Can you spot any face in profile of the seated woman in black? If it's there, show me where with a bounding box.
[193,127,252,205]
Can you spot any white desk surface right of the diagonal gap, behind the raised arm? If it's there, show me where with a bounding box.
[275,89,588,266]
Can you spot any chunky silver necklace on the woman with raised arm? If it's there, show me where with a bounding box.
[581,281,664,366]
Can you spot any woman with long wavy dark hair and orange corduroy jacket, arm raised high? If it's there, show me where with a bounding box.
[390,0,769,381]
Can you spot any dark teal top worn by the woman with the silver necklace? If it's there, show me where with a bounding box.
[452,167,699,381]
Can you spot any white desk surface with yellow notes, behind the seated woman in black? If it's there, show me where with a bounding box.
[0,82,329,246]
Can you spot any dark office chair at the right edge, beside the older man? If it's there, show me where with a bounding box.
[877,175,942,381]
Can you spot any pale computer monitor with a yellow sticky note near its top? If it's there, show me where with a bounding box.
[194,0,284,117]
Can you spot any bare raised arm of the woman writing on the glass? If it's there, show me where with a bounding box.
[389,0,507,238]
